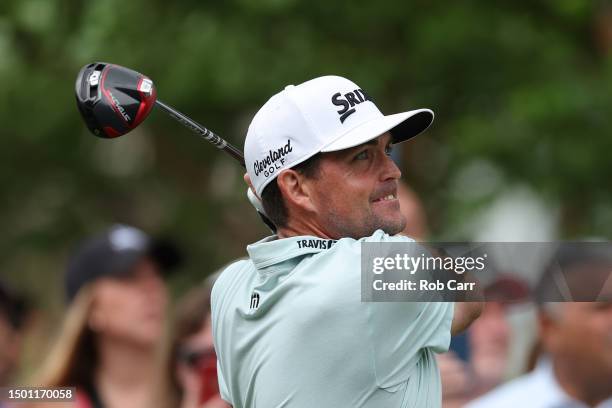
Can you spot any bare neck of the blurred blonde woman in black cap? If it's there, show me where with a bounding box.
[94,339,156,408]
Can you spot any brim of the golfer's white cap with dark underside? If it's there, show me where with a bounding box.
[321,109,434,153]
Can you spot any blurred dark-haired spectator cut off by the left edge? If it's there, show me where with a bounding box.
[0,282,28,396]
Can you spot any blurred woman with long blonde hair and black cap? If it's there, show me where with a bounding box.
[37,225,179,408]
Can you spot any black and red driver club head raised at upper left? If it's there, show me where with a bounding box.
[75,62,157,138]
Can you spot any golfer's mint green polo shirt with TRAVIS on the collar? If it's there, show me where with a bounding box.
[212,230,454,408]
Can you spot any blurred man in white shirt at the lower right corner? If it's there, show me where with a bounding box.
[468,244,612,408]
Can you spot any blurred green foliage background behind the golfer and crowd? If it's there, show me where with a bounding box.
[0,0,612,307]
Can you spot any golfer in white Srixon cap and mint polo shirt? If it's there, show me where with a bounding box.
[212,76,481,408]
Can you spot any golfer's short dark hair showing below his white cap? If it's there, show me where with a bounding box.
[261,153,321,228]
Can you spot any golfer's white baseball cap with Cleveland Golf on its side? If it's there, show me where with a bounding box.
[244,76,434,197]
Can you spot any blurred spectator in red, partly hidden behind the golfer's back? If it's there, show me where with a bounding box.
[171,282,229,408]
